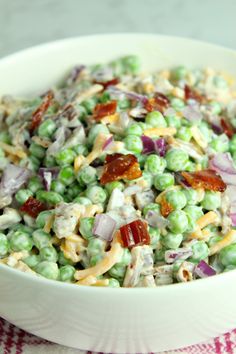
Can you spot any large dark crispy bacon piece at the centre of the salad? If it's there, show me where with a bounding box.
[100,154,142,184]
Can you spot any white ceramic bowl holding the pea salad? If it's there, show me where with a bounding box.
[0,34,236,353]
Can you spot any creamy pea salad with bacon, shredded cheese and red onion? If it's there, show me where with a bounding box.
[0,55,236,287]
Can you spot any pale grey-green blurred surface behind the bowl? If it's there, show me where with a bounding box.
[0,0,236,57]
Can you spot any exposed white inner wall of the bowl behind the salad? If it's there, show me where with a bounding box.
[0,34,236,95]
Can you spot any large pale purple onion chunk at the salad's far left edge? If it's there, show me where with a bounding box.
[0,164,31,196]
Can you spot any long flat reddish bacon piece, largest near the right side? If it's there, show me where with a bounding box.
[181,170,227,192]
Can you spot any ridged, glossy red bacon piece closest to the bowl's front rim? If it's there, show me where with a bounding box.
[120,220,150,248]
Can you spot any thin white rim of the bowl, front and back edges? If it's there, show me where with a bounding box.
[0,32,236,296]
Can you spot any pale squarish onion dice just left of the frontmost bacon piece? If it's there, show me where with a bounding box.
[93,214,116,241]
